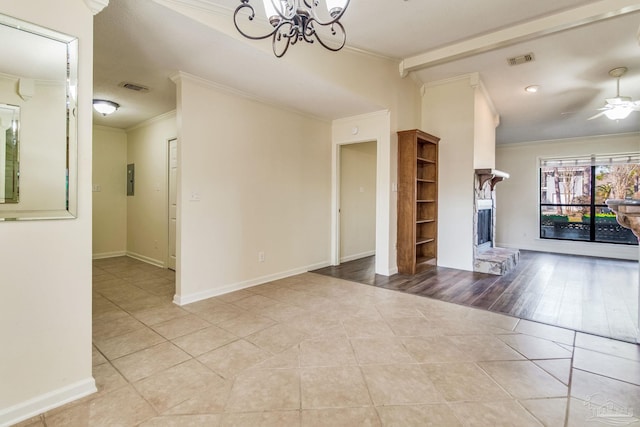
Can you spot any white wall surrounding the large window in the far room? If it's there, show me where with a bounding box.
[496,134,640,260]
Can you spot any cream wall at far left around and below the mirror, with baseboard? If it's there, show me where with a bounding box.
[0,0,95,424]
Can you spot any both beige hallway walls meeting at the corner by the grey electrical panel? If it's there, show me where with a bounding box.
[93,111,177,267]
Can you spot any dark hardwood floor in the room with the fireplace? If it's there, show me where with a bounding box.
[314,251,638,342]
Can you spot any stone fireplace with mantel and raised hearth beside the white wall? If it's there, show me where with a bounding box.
[473,169,520,275]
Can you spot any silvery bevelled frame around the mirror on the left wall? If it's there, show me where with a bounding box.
[0,14,78,221]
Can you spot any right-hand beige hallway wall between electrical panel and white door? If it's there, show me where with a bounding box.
[125,112,177,267]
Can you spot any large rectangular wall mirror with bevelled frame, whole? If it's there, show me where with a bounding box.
[0,14,78,221]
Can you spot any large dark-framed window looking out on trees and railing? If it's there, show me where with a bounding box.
[540,153,640,245]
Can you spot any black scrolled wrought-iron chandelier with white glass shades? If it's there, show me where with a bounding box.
[233,0,350,58]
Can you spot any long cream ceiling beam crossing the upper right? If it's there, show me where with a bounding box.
[400,0,640,77]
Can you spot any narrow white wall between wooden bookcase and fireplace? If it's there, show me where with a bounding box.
[422,77,475,271]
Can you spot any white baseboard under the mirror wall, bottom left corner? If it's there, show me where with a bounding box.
[0,377,98,427]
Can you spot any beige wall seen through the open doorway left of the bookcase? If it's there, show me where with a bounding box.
[340,142,377,262]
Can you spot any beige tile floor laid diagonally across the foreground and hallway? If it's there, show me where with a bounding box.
[13,258,640,427]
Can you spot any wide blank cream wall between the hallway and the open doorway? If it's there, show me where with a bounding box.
[175,74,331,304]
